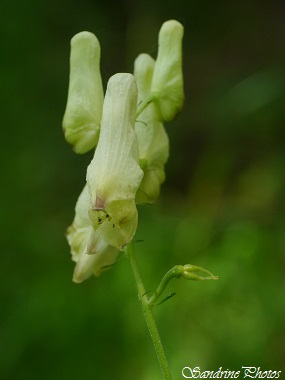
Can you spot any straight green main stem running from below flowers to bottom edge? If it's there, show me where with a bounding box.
[127,243,172,380]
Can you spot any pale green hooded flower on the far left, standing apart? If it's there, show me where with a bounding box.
[63,32,104,153]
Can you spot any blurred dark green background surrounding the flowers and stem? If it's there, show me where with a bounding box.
[0,0,285,380]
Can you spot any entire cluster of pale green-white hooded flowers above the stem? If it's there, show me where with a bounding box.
[63,20,184,283]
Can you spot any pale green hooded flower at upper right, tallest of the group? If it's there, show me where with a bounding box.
[151,20,184,121]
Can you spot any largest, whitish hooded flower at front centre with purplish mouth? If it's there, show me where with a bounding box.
[87,73,143,250]
